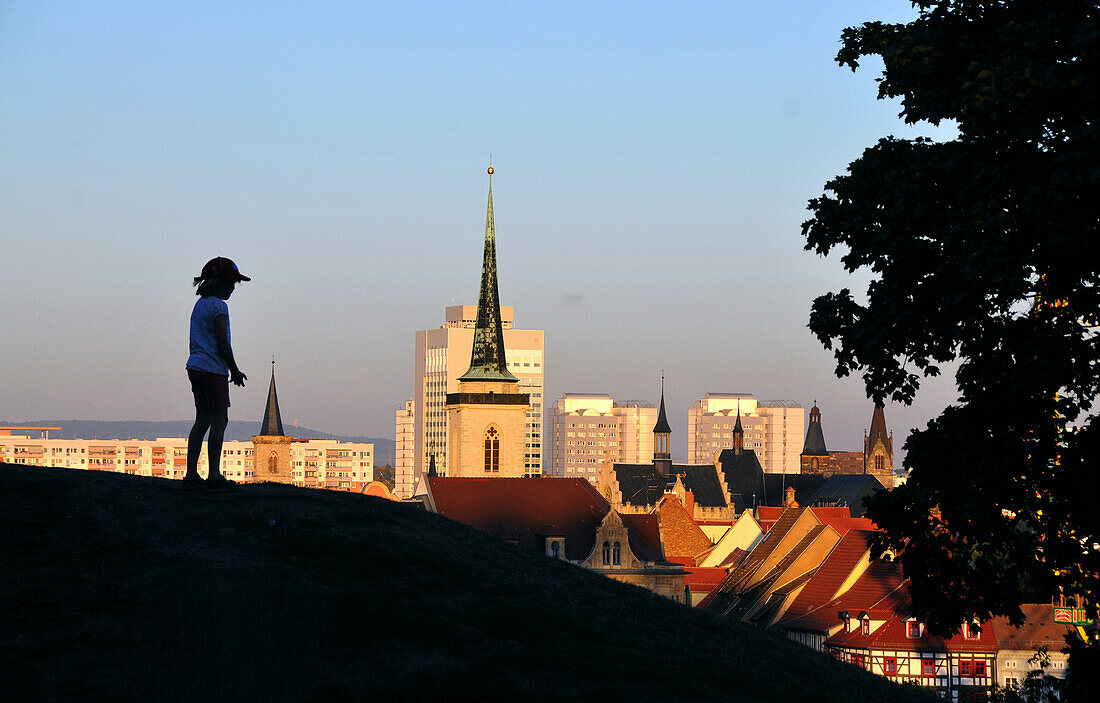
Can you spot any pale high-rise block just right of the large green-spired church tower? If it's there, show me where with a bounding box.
[546,393,657,484]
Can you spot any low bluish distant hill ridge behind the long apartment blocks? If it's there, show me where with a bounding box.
[0,420,394,464]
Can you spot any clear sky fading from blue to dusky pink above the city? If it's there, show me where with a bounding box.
[0,0,955,459]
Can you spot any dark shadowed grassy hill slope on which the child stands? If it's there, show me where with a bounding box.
[0,464,938,703]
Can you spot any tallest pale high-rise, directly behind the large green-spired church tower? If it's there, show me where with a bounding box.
[410,305,546,481]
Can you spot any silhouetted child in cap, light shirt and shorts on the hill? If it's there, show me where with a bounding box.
[184,256,252,488]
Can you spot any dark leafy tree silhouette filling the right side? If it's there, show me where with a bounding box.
[803,0,1100,677]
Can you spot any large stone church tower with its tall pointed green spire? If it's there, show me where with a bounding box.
[446,166,530,477]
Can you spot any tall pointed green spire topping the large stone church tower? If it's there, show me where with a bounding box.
[459,166,519,383]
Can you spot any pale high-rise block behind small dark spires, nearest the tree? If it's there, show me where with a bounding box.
[688,393,806,473]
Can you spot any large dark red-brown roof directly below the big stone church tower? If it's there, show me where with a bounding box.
[427,476,611,560]
